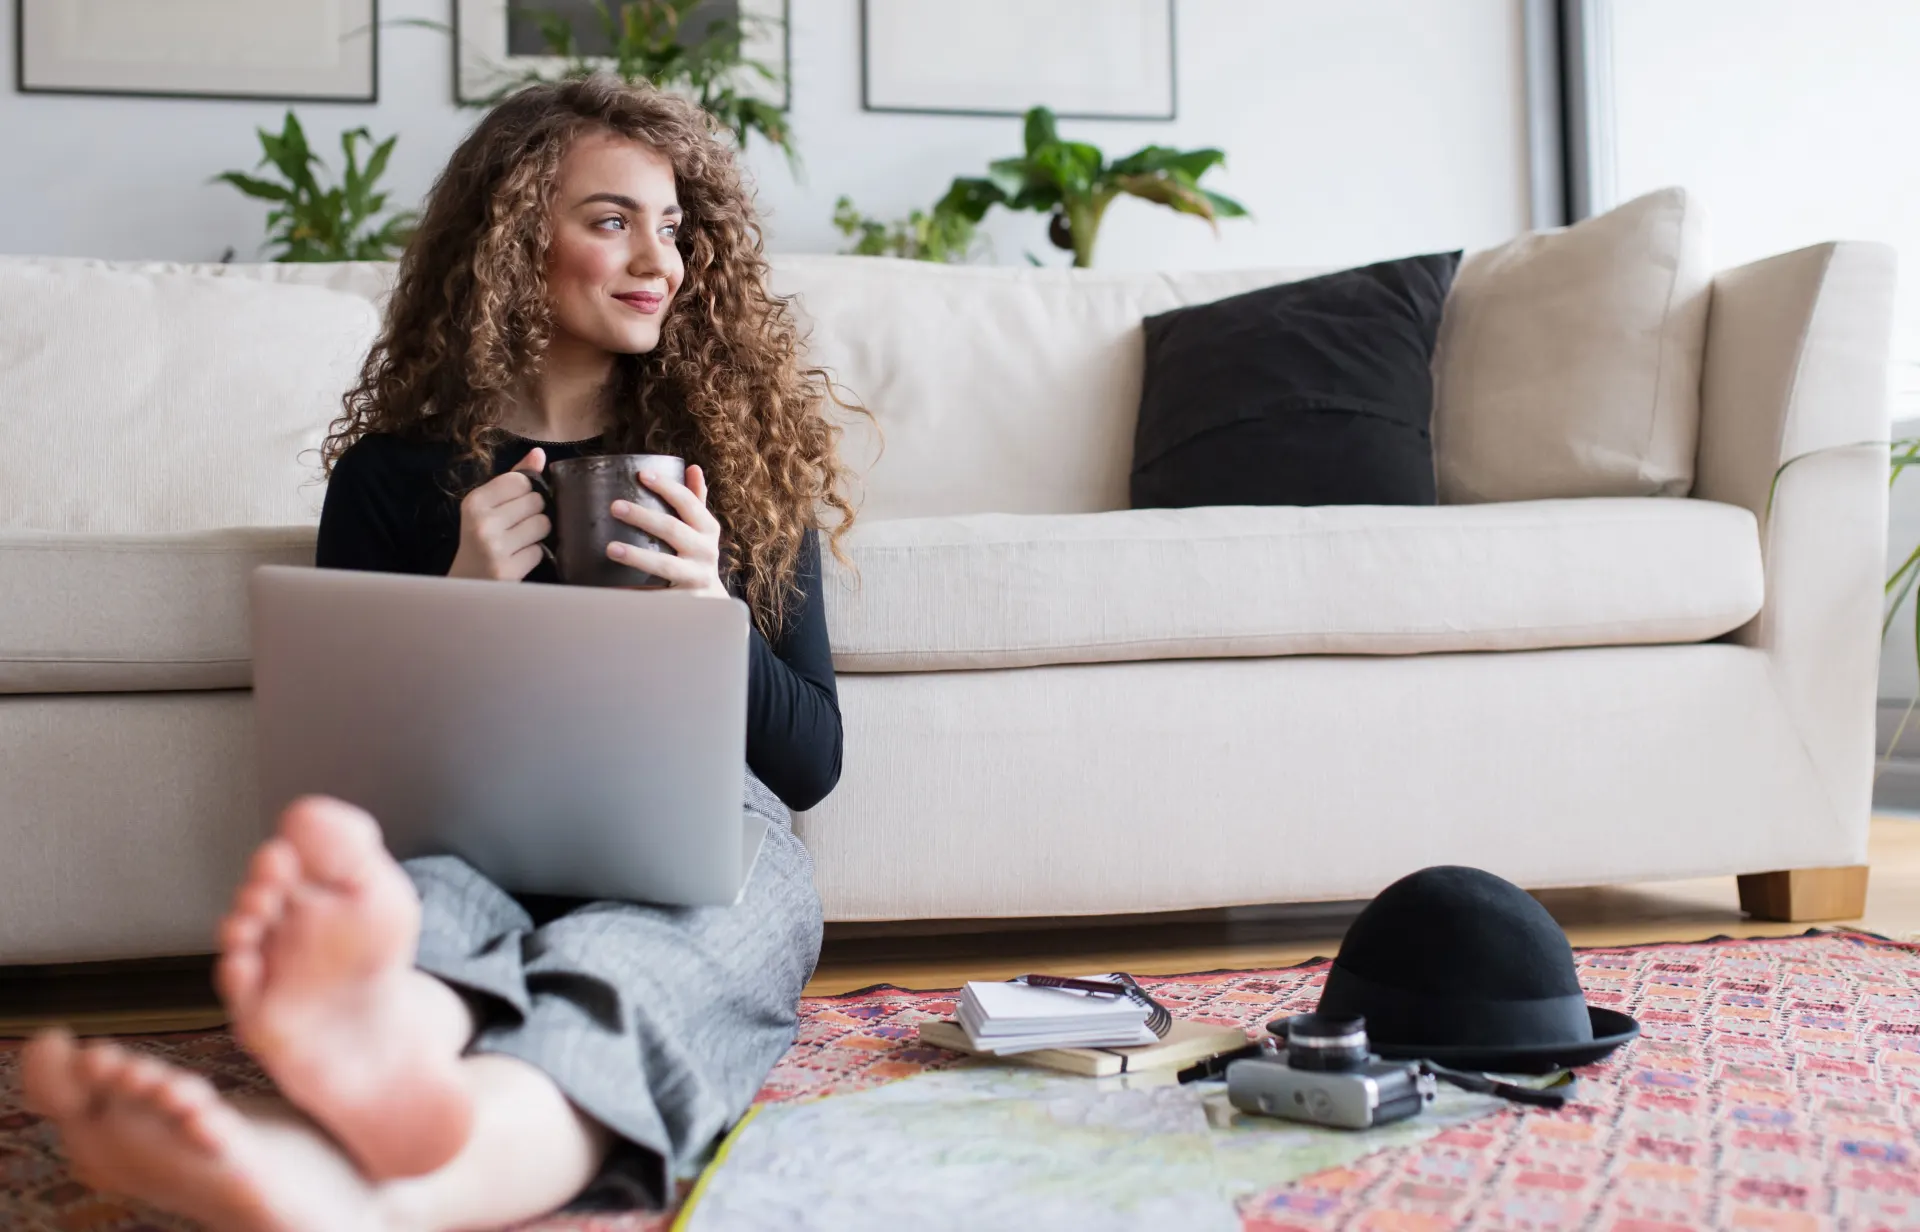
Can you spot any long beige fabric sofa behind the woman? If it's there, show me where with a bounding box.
[0,192,1893,963]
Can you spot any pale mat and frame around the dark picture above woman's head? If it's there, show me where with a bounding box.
[453,0,793,111]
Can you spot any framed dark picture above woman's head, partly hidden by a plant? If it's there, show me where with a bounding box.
[453,0,793,109]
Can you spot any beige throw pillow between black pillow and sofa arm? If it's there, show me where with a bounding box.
[1432,188,1711,505]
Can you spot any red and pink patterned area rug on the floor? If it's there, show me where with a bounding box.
[0,933,1920,1232]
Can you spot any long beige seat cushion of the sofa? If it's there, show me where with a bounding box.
[0,499,1761,693]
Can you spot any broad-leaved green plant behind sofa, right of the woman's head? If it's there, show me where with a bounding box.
[935,107,1246,269]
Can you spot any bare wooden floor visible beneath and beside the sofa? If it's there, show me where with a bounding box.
[0,817,1920,1036]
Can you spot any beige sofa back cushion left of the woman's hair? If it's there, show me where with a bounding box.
[0,261,380,533]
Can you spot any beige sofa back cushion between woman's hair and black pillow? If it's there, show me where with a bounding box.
[772,255,1300,518]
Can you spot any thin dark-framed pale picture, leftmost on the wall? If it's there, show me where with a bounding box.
[13,0,380,102]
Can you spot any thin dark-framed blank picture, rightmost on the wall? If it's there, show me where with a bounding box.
[860,0,1175,119]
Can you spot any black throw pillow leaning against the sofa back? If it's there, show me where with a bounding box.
[1131,251,1459,509]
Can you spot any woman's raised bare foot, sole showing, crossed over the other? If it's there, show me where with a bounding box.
[215,796,472,1180]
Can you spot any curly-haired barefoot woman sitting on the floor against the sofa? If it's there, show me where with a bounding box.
[25,79,852,1232]
